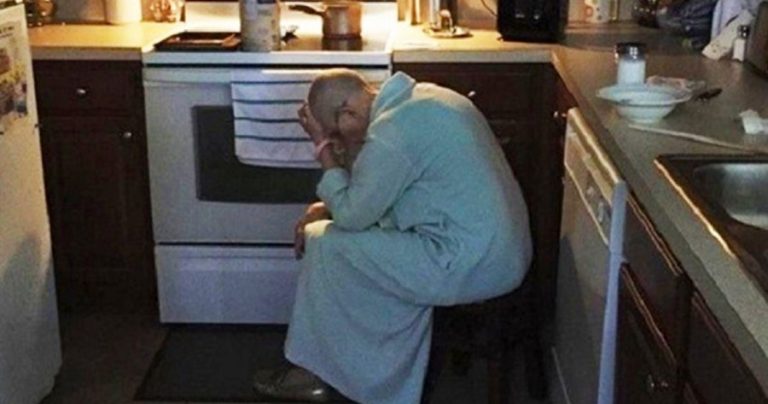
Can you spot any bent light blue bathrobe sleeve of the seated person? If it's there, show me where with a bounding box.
[317,131,413,231]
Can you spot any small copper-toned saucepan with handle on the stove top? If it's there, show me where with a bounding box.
[288,1,363,39]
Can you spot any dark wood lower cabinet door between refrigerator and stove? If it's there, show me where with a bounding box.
[41,117,155,310]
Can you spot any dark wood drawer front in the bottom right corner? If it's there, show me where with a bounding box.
[687,293,768,404]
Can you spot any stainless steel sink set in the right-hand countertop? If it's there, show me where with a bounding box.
[656,155,768,291]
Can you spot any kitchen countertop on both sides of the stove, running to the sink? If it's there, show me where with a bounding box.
[30,18,768,392]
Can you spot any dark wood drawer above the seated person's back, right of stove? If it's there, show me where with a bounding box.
[395,63,544,119]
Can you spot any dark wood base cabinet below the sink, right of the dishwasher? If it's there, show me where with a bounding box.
[615,198,768,404]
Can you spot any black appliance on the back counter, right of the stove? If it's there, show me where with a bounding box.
[496,0,568,42]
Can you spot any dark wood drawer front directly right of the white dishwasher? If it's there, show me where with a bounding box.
[624,199,692,360]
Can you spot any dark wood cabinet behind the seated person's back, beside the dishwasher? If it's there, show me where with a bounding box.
[393,63,565,318]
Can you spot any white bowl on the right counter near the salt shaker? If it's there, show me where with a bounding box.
[597,84,691,123]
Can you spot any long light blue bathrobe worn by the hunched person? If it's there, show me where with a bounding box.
[285,73,531,404]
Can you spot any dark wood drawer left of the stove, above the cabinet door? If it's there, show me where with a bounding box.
[34,61,143,116]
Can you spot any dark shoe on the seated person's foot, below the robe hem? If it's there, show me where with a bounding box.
[253,366,331,403]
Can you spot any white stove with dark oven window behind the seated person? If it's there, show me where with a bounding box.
[143,2,397,323]
